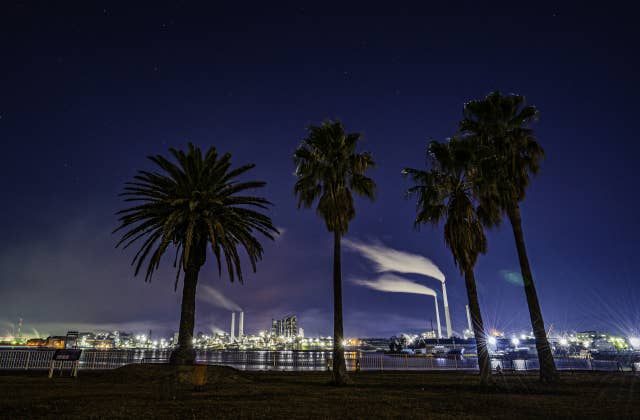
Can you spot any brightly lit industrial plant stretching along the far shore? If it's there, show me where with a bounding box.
[0,307,640,357]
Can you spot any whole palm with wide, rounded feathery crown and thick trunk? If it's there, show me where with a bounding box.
[114,143,278,364]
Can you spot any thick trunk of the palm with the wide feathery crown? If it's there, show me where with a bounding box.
[171,264,200,365]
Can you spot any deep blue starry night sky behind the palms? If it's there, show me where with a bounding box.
[0,2,640,337]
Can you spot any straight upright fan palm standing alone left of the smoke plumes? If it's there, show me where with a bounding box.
[293,121,376,385]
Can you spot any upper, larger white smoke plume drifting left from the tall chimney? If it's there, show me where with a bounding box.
[343,239,445,283]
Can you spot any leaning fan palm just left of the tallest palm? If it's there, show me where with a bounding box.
[403,138,491,385]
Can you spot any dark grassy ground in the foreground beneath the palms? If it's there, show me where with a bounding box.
[0,365,640,419]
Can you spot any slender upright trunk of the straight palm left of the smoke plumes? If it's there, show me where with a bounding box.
[333,232,349,385]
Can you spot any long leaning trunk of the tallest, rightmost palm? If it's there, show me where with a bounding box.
[507,202,558,383]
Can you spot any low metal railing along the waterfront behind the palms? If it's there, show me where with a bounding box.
[0,349,640,373]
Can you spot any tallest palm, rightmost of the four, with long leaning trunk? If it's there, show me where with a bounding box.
[459,92,558,382]
